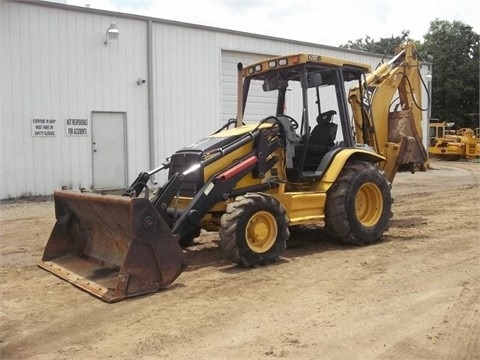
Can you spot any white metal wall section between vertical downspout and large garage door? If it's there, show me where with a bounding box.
[152,23,220,167]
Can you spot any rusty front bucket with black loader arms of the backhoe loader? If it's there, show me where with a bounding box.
[38,124,282,302]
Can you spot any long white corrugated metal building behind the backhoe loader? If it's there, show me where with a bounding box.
[0,0,428,199]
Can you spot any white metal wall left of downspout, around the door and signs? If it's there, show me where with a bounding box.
[0,1,148,198]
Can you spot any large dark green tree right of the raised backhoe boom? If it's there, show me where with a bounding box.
[418,19,480,128]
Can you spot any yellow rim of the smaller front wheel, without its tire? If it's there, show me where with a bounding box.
[245,211,278,253]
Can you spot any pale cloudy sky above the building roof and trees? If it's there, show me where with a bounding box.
[55,0,480,46]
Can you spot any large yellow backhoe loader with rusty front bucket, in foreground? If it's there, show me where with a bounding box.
[39,42,427,302]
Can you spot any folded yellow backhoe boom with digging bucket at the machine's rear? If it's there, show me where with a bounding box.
[348,43,428,182]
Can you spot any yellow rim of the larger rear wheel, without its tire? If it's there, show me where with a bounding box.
[355,182,383,226]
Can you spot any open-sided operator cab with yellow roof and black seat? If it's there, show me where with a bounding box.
[243,62,365,182]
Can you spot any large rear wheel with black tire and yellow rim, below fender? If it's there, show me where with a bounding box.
[325,161,392,245]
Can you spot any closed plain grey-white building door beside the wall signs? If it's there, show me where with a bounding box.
[92,112,127,190]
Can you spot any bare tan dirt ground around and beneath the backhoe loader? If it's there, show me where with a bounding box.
[0,161,480,360]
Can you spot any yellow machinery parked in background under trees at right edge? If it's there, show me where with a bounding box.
[428,122,480,161]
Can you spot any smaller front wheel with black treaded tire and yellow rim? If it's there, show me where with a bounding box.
[219,193,290,267]
